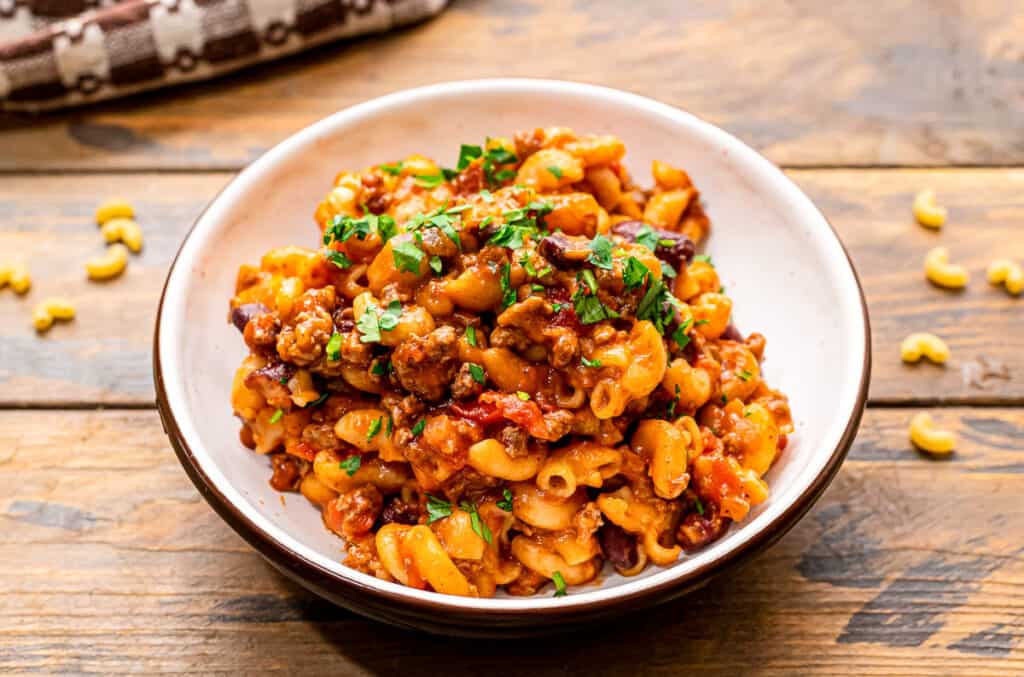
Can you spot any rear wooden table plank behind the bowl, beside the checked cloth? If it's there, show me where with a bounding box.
[0,0,1024,170]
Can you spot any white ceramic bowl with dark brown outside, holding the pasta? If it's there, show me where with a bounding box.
[154,80,870,634]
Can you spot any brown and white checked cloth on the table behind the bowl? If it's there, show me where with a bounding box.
[0,0,447,112]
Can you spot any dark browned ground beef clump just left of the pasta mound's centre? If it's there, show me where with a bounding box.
[391,327,459,401]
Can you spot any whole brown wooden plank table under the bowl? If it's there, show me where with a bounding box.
[0,0,1024,677]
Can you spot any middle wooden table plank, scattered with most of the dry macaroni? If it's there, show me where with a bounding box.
[0,170,1024,406]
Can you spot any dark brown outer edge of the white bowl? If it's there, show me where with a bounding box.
[153,144,871,627]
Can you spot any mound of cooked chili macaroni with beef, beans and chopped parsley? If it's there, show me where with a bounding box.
[230,128,793,596]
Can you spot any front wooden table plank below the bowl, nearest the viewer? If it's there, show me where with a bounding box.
[0,408,1024,677]
